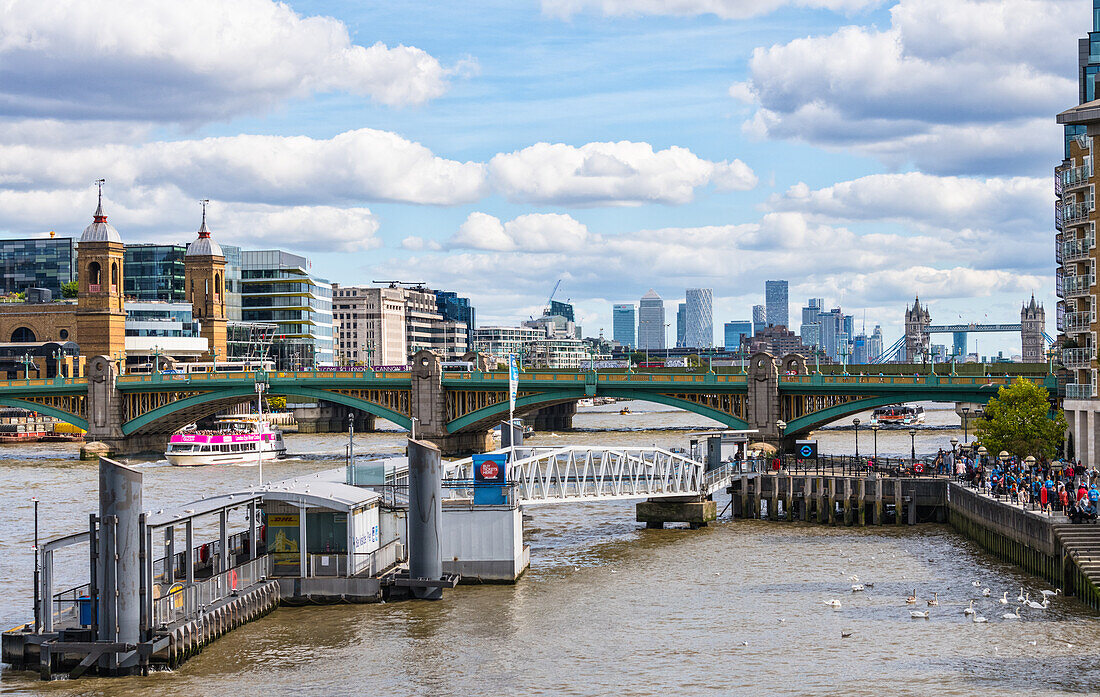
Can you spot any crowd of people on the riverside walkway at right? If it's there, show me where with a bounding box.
[933,450,1100,520]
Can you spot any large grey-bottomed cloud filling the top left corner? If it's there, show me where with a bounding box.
[0,0,448,122]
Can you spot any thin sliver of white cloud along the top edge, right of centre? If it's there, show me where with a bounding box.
[542,0,884,20]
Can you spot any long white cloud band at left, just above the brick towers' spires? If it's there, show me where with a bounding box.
[0,129,485,204]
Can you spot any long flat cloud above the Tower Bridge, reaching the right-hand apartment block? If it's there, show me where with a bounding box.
[768,172,1053,231]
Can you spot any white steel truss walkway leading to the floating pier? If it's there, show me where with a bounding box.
[447,445,733,505]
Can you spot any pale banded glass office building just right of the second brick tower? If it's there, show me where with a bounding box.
[241,250,336,369]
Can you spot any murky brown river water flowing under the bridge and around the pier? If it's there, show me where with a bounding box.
[0,402,1100,696]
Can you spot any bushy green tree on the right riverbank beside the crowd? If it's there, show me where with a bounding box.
[975,378,1066,457]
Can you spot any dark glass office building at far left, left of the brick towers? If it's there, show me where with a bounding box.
[0,237,76,300]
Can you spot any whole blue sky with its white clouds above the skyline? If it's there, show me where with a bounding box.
[0,0,1091,354]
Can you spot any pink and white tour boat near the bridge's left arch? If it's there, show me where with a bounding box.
[164,421,286,467]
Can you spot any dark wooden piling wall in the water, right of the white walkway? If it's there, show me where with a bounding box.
[728,472,945,525]
